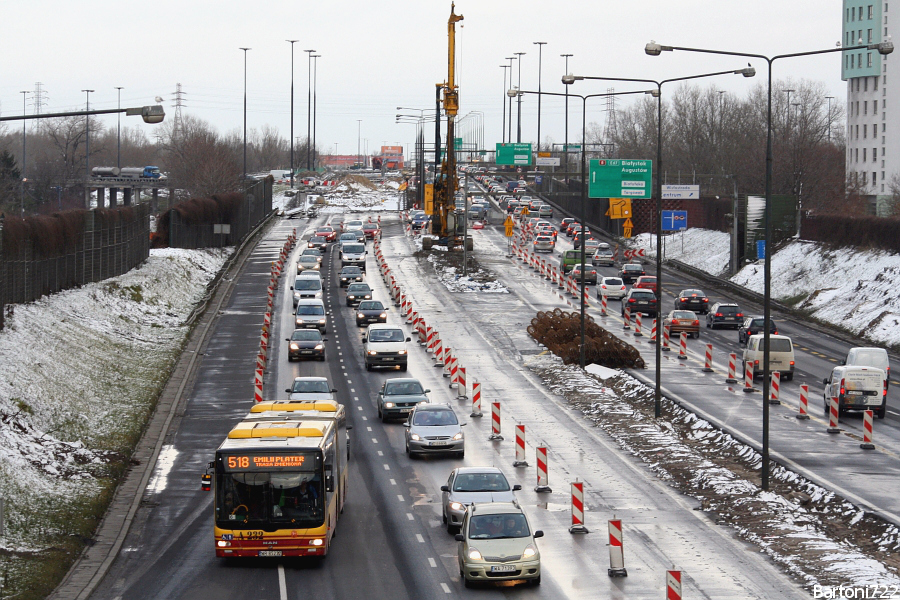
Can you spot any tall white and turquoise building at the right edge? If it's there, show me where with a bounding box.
[841,0,900,214]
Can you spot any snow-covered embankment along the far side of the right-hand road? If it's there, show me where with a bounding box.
[634,229,900,347]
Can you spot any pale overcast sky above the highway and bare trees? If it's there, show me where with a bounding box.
[0,0,846,162]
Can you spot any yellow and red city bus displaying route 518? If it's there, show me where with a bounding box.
[213,410,348,557]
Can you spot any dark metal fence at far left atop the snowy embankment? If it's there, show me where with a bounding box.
[0,205,150,329]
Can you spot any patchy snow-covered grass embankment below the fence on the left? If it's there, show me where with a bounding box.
[0,248,233,552]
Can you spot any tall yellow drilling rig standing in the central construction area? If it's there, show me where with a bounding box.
[422,3,472,250]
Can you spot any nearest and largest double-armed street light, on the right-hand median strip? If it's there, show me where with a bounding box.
[644,40,894,490]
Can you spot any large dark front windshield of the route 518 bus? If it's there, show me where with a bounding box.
[216,456,325,531]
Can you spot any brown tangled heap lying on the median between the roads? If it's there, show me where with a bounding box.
[528,308,644,369]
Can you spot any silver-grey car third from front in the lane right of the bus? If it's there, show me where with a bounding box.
[403,404,466,458]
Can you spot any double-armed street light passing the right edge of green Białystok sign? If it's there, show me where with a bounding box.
[563,67,756,418]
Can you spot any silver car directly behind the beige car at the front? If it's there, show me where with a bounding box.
[441,467,522,533]
